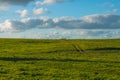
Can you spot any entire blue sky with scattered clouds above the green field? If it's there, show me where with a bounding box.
[0,0,120,39]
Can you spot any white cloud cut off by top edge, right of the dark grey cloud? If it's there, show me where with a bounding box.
[35,0,72,6]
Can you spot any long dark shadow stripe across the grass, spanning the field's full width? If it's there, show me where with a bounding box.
[0,57,120,63]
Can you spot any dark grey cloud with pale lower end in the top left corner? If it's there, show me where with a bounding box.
[0,0,34,10]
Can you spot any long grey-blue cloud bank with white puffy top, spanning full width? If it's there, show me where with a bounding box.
[0,14,120,32]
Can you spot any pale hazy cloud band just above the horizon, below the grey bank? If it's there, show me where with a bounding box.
[0,29,120,39]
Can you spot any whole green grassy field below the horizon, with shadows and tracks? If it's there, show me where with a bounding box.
[0,39,120,80]
